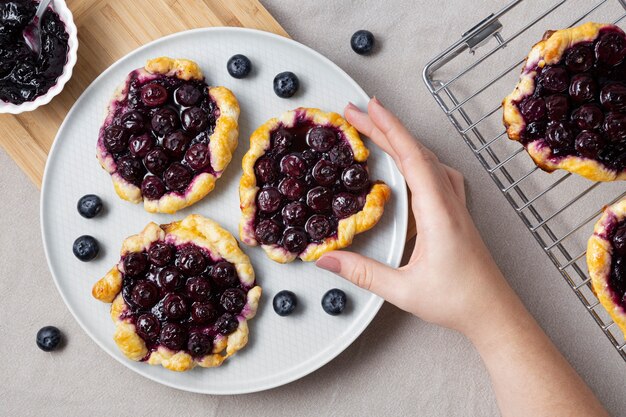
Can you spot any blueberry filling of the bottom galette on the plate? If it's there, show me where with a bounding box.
[121,241,251,357]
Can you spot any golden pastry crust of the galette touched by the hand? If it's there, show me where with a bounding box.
[239,107,391,263]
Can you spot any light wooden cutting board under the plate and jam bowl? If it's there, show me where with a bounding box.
[0,0,416,238]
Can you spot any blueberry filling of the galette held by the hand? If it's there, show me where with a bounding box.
[254,121,371,253]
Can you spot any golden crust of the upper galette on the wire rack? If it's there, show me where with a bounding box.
[502,22,626,181]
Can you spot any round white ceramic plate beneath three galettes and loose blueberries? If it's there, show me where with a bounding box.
[41,28,408,394]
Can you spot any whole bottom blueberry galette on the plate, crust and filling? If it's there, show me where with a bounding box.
[92,214,261,371]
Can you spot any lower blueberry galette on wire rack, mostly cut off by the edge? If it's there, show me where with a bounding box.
[587,199,626,334]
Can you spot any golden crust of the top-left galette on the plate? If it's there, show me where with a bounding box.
[97,57,240,214]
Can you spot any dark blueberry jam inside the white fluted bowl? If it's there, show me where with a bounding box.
[0,0,69,104]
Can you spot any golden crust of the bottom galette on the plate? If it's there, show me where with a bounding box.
[92,214,261,371]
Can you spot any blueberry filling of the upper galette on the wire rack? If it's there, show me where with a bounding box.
[517,28,626,171]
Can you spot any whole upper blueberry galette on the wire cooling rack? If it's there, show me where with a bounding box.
[503,23,626,181]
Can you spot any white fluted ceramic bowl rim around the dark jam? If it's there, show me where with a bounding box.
[0,0,78,114]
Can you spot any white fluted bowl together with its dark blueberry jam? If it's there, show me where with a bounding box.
[0,0,78,114]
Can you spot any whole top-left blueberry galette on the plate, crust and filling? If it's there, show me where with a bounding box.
[97,57,239,213]
